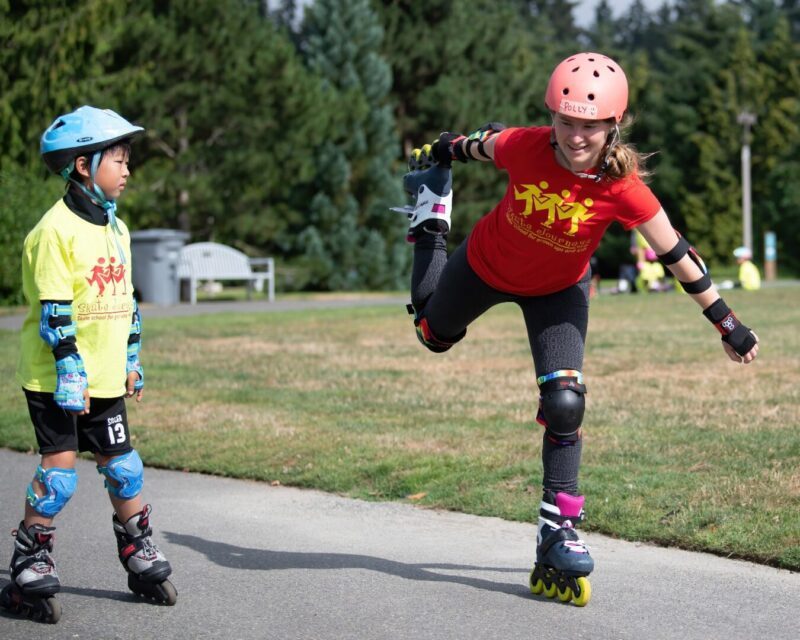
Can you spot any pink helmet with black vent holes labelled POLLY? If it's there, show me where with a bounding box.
[544,53,628,122]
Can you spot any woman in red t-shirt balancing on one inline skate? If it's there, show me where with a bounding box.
[396,53,758,606]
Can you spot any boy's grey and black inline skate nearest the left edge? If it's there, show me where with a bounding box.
[0,522,61,623]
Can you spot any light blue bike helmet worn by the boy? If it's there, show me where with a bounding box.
[39,106,144,179]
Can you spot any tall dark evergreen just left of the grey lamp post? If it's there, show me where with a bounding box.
[640,0,742,252]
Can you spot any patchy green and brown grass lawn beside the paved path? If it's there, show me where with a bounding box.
[0,287,800,570]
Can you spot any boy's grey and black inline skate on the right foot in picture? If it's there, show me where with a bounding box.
[113,504,178,606]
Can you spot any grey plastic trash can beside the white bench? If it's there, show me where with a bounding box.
[131,229,189,306]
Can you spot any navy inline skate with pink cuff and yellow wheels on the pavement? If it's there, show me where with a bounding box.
[530,491,594,607]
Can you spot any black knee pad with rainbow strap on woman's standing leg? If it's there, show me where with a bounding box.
[536,370,586,445]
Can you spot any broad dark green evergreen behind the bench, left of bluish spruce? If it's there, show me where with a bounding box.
[112,0,329,264]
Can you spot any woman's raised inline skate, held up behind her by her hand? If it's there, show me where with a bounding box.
[392,145,453,243]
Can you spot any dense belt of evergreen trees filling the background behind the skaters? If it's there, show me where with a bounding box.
[0,0,800,302]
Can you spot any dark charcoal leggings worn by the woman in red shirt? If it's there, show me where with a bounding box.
[411,234,591,494]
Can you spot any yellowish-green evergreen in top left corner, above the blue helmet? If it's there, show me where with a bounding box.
[0,0,131,176]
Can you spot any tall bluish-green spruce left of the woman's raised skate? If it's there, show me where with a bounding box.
[298,0,410,289]
